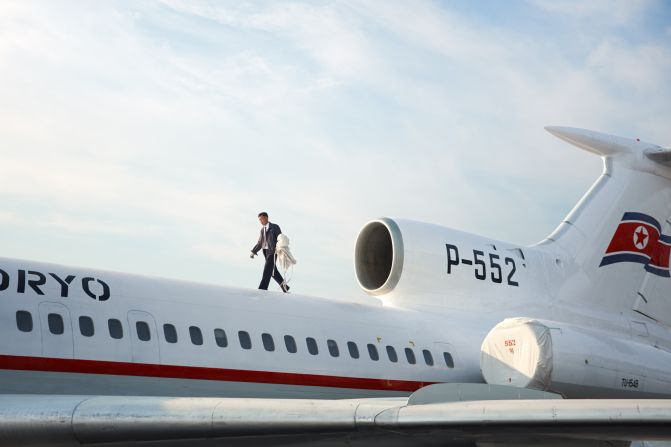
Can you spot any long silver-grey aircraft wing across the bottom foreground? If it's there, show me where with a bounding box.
[0,385,671,446]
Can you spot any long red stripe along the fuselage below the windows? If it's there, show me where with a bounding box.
[0,355,435,392]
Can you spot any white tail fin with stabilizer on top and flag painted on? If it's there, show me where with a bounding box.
[539,127,671,325]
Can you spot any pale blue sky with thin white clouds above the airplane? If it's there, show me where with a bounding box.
[0,0,671,301]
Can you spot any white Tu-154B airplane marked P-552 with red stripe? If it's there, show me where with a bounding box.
[0,127,671,446]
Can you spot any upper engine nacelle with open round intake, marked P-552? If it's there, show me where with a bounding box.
[354,217,543,306]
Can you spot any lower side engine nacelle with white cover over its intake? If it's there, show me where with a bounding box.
[480,318,671,398]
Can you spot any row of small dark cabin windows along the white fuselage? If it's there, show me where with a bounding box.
[16,310,454,368]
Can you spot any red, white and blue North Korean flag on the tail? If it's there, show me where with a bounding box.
[599,213,671,278]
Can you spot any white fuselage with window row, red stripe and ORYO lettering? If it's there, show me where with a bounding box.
[0,260,492,398]
